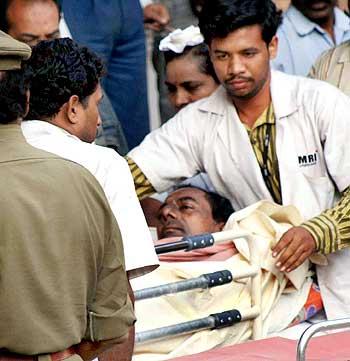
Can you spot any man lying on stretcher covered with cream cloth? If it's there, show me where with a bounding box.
[133,187,322,361]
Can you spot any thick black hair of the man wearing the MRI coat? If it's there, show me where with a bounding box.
[199,0,282,45]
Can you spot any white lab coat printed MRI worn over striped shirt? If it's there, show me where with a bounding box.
[129,72,350,318]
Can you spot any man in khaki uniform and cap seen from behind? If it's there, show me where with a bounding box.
[0,32,135,361]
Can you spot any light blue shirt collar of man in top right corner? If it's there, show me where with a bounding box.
[285,6,350,39]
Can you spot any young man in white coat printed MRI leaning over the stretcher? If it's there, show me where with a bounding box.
[128,0,350,318]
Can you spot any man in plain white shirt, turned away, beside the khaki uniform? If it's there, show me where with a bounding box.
[22,38,158,278]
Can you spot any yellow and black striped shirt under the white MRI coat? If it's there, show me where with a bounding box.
[127,105,350,254]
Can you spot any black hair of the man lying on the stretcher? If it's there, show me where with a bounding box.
[174,184,234,223]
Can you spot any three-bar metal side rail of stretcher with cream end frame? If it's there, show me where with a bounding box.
[135,231,262,343]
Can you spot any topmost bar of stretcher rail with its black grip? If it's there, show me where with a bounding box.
[155,233,214,254]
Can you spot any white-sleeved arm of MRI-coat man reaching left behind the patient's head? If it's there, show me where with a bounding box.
[127,104,202,199]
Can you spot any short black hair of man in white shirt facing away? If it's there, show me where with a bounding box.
[23,38,104,120]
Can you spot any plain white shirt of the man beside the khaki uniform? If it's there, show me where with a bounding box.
[22,120,158,278]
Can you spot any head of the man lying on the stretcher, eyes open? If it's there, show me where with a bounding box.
[158,186,233,238]
